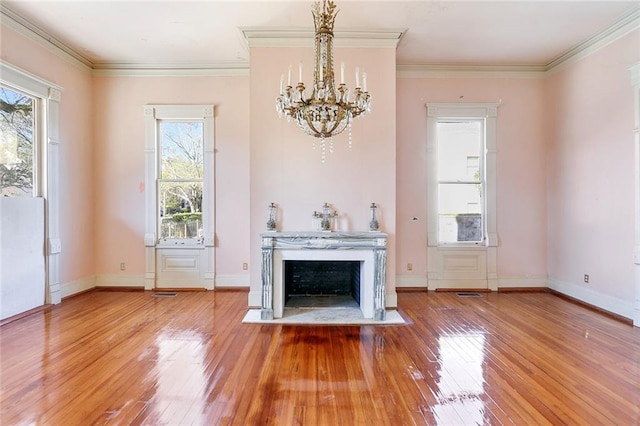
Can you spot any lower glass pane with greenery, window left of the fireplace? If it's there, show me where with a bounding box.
[158,181,202,239]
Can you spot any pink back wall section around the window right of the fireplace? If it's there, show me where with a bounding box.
[397,78,546,286]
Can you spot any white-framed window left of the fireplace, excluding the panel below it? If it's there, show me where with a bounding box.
[145,105,214,246]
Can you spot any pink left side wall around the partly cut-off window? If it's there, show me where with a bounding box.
[0,25,95,283]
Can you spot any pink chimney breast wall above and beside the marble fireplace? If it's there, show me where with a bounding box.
[250,48,396,304]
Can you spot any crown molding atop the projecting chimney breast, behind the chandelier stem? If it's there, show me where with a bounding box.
[240,27,406,49]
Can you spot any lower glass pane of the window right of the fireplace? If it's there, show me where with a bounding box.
[438,184,483,243]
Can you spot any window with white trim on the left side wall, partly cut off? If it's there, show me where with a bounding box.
[0,61,63,304]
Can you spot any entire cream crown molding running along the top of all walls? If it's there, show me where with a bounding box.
[0,2,640,78]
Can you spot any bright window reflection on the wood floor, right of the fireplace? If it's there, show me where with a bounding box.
[432,332,486,425]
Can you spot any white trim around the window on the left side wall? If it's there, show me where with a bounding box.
[0,61,63,304]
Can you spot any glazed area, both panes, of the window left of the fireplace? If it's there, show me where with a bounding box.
[158,120,204,242]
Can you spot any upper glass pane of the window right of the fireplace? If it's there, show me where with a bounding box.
[437,120,483,182]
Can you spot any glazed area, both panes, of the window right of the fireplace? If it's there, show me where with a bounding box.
[436,119,484,243]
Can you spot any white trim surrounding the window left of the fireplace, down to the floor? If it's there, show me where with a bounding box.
[144,105,215,290]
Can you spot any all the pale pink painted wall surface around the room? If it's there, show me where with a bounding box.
[1,15,640,318]
